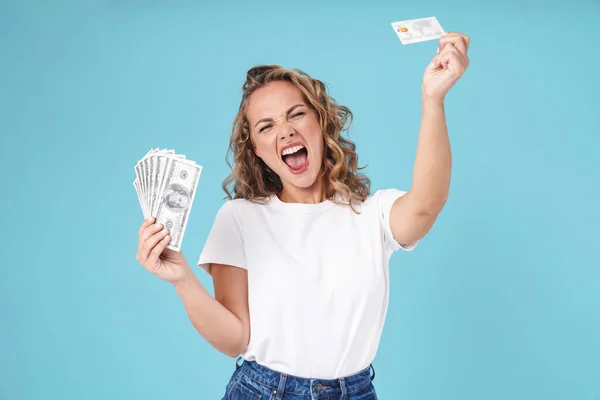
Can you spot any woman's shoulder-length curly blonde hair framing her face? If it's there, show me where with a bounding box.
[222,65,371,209]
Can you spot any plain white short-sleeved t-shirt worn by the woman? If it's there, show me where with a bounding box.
[198,189,417,379]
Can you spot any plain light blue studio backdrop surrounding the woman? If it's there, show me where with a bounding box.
[0,0,600,400]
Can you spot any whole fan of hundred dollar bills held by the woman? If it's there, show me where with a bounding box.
[133,148,202,251]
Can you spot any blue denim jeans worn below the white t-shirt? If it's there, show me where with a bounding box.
[222,357,377,400]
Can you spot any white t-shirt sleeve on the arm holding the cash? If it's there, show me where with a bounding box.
[197,200,247,274]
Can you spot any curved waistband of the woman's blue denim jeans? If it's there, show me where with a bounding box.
[236,358,375,399]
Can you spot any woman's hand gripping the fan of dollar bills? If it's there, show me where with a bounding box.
[135,218,193,284]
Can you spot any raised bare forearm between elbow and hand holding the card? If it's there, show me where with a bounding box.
[411,96,452,214]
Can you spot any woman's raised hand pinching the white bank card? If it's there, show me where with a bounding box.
[421,32,471,102]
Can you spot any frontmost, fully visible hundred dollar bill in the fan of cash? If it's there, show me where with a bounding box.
[155,154,202,251]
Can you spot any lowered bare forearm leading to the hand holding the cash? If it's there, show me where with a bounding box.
[174,274,246,357]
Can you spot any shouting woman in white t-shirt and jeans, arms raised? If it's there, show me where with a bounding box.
[137,33,470,400]
